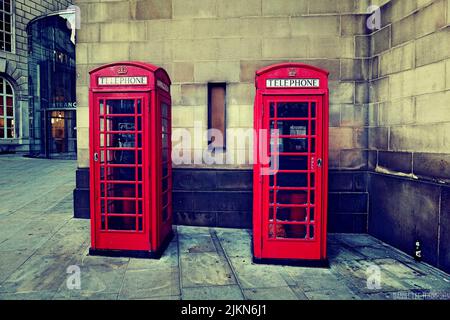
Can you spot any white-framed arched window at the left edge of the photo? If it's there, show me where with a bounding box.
[0,77,15,139]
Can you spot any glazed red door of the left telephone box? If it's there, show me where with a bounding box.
[91,93,151,251]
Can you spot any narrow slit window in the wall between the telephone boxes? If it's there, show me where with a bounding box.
[208,83,226,149]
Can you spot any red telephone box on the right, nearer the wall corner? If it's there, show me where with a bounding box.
[253,63,328,265]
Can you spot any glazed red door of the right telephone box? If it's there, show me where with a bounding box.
[261,95,326,260]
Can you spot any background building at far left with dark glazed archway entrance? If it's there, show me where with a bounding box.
[0,0,76,157]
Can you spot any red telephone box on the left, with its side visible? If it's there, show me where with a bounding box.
[89,62,173,258]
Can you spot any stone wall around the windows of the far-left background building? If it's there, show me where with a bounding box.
[0,0,72,152]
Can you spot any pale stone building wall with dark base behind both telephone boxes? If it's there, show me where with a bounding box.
[74,0,450,271]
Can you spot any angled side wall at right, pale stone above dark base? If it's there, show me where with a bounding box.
[368,0,450,271]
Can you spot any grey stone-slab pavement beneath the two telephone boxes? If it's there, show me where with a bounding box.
[0,155,450,300]
